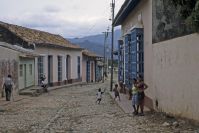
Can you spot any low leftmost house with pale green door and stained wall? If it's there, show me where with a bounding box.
[0,42,37,94]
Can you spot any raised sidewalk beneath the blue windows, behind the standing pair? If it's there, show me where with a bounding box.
[109,91,149,114]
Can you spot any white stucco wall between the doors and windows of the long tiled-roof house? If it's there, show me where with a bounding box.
[35,47,82,82]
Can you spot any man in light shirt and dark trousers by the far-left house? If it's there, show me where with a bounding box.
[3,75,13,101]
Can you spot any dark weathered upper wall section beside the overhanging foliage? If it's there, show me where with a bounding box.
[153,0,192,43]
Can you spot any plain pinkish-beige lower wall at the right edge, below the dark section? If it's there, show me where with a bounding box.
[153,34,199,120]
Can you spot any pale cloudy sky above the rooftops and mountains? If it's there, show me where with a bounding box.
[0,0,125,38]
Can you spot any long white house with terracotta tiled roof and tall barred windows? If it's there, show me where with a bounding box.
[0,22,82,87]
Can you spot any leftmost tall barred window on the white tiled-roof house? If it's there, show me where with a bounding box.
[38,56,44,84]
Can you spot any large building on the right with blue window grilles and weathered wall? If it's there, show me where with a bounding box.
[114,0,199,120]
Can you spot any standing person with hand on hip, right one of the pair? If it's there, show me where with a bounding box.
[137,76,148,116]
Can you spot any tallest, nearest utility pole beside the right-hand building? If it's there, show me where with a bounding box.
[110,0,115,91]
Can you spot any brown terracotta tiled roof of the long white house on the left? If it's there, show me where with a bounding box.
[0,21,80,49]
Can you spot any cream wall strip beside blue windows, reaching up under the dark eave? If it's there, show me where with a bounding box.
[122,0,153,100]
